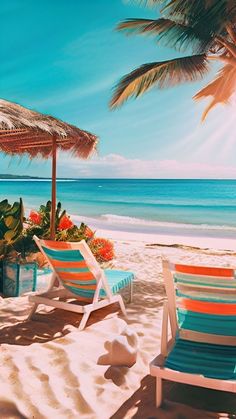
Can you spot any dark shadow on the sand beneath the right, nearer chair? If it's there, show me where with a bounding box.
[110,375,236,419]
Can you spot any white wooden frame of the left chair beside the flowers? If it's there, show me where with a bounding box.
[28,236,132,330]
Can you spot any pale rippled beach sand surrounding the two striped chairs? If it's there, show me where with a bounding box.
[0,232,236,419]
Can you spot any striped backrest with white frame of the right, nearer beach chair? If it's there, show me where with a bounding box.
[163,260,236,345]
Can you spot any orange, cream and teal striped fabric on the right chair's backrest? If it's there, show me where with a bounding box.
[174,265,236,345]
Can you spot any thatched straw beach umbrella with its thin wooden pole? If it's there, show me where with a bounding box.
[0,99,98,239]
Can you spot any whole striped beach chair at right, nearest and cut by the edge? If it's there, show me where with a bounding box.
[150,260,236,407]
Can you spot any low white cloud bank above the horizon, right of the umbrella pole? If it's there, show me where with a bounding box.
[58,154,236,179]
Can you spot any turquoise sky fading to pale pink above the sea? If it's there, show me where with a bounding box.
[0,0,236,178]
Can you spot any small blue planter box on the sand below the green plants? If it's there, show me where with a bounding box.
[3,261,37,297]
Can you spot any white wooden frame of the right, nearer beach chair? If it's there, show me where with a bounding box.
[150,259,236,407]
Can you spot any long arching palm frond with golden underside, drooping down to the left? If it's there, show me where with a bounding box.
[110,54,208,108]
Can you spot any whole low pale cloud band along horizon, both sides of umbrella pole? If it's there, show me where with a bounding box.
[0,153,236,179]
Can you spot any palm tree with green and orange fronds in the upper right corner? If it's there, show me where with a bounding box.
[110,0,236,120]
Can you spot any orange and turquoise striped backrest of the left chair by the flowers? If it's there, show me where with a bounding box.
[34,236,105,300]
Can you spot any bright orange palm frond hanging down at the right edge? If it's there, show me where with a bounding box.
[193,64,236,121]
